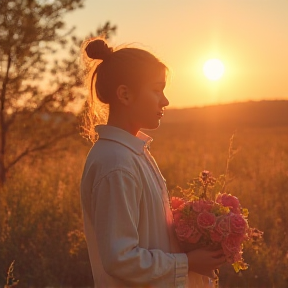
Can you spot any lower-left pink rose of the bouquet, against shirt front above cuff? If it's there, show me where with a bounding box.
[175,220,201,243]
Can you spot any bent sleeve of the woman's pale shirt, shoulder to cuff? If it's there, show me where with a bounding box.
[92,170,188,287]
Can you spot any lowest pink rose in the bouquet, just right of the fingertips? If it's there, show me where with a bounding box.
[221,235,242,263]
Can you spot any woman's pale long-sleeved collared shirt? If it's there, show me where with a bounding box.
[81,125,188,288]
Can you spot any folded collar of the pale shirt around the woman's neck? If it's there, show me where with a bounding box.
[95,125,153,154]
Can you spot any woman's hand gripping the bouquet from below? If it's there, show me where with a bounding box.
[186,248,226,279]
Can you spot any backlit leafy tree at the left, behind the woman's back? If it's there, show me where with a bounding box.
[0,0,116,188]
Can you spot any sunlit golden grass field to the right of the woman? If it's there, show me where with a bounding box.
[150,123,288,288]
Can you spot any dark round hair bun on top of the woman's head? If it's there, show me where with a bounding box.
[85,39,113,60]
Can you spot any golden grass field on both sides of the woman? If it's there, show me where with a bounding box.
[0,102,288,288]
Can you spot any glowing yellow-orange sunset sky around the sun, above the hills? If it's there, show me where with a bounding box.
[65,0,288,108]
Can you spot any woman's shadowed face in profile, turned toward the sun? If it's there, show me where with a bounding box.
[130,68,169,130]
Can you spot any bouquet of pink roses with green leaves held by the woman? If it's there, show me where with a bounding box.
[170,171,263,272]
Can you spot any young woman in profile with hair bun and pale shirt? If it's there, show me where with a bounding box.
[81,38,225,288]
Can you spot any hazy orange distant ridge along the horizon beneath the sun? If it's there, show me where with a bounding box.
[163,100,288,128]
